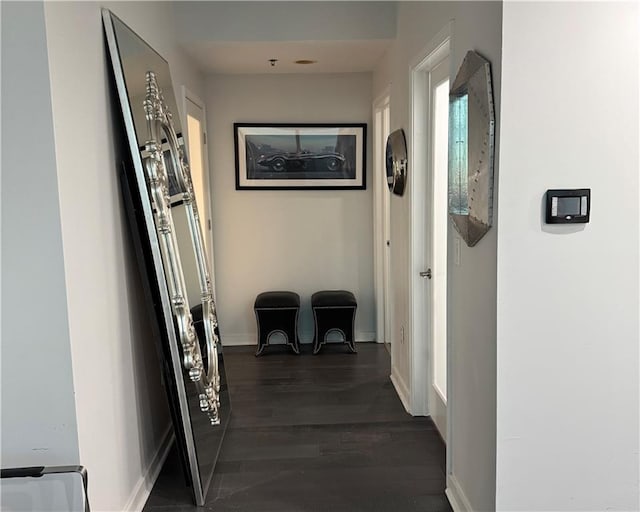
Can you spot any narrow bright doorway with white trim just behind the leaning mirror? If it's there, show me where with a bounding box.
[184,89,215,299]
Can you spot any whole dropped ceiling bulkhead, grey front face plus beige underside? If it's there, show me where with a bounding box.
[174,0,397,74]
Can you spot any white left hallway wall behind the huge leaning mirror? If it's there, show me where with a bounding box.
[40,2,203,510]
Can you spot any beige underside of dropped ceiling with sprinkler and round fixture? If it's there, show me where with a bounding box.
[182,39,392,74]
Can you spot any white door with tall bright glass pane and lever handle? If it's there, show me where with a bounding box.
[425,58,449,440]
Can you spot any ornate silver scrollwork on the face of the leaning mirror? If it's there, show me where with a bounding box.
[144,71,220,425]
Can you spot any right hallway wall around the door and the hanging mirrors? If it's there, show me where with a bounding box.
[373,2,502,510]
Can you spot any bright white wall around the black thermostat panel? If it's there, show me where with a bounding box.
[496,2,640,511]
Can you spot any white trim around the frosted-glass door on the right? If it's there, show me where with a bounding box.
[408,22,453,416]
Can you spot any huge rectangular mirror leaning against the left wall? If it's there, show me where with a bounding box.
[103,10,231,505]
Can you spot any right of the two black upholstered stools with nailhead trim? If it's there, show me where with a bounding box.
[311,290,358,354]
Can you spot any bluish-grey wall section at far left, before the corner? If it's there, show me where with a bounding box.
[1,2,79,468]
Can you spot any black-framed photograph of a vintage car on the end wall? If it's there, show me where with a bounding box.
[233,123,367,190]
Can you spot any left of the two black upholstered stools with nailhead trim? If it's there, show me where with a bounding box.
[253,292,300,356]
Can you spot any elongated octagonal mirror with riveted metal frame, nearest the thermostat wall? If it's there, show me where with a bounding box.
[449,51,495,247]
